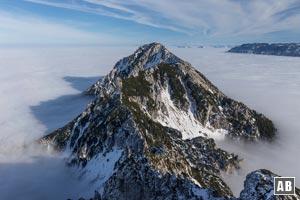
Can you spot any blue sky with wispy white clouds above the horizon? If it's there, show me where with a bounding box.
[0,0,300,45]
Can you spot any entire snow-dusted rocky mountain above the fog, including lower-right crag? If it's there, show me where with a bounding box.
[40,43,298,199]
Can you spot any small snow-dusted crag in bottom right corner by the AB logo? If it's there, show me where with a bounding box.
[240,169,300,200]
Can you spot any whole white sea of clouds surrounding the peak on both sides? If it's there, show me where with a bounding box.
[0,46,300,199]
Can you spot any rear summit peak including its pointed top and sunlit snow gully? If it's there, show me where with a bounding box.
[86,43,275,140]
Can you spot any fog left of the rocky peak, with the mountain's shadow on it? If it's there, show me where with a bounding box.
[0,47,134,200]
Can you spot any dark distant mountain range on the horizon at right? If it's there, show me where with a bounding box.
[228,43,300,57]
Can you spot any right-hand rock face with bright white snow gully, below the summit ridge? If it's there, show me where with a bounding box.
[122,63,275,140]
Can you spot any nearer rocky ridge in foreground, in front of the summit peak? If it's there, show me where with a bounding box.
[41,93,239,199]
